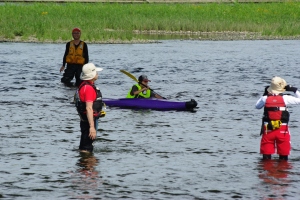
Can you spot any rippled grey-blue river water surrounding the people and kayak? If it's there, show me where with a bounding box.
[0,40,300,200]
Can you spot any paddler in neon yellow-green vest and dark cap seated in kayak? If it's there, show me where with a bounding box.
[126,75,164,99]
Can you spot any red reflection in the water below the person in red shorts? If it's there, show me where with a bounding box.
[258,160,293,200]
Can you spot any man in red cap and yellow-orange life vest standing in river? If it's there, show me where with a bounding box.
[60,28,89,87]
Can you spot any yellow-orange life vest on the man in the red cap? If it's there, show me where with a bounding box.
[66,40,85,65]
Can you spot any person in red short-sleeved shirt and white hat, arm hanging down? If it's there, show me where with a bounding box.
[75,63,105,152]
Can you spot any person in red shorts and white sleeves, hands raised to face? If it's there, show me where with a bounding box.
[255,76,300,160]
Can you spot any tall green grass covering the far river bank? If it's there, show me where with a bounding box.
[0,1,300,42]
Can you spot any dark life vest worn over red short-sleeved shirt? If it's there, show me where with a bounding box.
[75,81,103,120]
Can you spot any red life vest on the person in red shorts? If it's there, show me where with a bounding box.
[264,94,290,123]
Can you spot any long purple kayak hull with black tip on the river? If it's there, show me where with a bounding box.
[103,98,197,110]
